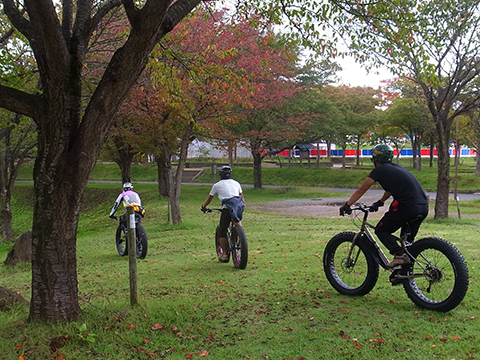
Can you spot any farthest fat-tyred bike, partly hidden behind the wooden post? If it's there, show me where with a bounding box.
[112,213,148,259]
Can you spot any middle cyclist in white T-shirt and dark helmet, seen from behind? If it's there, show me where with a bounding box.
[202,165,245,261]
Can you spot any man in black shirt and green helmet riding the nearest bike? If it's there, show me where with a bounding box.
[340,144,428,267]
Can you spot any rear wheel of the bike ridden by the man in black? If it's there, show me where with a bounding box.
[403,237,468,312]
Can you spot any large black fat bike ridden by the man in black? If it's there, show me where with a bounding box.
[323,205,468,312]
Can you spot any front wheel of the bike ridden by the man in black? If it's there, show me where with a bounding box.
[323,232,378,296]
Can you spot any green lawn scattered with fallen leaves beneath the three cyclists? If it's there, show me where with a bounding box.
[0,184,480,360]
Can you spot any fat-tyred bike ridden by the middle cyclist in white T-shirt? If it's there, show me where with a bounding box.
[202,209,248,269]
